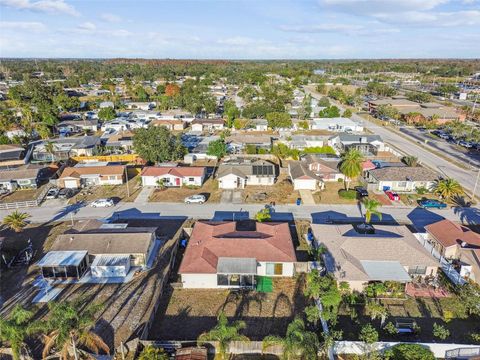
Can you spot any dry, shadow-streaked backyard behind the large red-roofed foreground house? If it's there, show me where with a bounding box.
[149,277,306,340]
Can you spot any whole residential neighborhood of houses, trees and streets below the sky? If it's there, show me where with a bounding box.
[0,59,480,360]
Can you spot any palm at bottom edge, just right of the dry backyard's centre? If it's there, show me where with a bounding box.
[263,317,320,360]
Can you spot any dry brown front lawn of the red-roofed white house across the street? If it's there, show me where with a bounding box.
[149,178,222,203]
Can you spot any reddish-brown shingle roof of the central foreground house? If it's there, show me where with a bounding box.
[179,221,296,274]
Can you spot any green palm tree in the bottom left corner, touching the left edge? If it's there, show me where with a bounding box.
[0,305,38,360]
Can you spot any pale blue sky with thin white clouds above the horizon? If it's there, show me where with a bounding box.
[0,0,480,59]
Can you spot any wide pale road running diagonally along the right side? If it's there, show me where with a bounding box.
[305,87,480,195]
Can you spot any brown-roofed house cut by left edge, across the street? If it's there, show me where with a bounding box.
[0,164,50,191]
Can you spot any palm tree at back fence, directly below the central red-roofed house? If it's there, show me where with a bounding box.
[197,311,250,359]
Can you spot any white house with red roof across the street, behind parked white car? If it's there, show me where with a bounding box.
[140,166,207,187]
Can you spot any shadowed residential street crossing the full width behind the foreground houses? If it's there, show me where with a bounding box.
[0,202,480,228]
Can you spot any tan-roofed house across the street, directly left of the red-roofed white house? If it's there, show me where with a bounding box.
[57,164,125,189]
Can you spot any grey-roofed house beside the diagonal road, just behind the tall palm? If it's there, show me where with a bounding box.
[328,133,385,156]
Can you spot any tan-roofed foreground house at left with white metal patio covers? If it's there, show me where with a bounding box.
[36,220,157,280]
